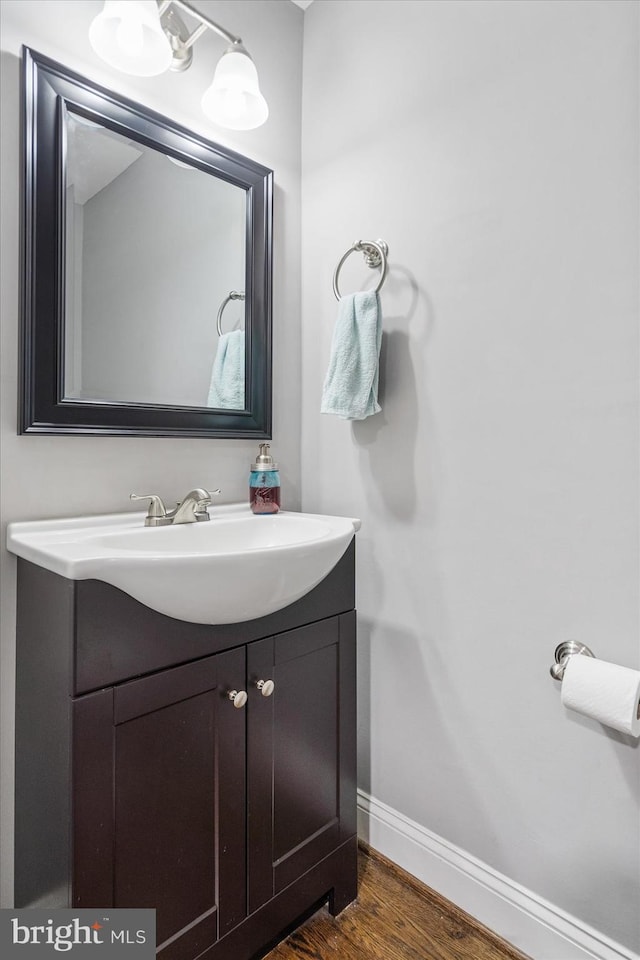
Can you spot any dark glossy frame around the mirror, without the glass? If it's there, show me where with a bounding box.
[19,48,273,438]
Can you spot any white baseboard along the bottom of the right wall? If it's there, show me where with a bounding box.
[358,790,640,960]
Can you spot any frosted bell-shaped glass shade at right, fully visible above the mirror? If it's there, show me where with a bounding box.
[202,47,269,130]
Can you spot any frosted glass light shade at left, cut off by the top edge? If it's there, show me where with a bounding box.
[89,0,171,77]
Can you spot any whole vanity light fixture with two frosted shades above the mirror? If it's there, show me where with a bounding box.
[89,0,269,130]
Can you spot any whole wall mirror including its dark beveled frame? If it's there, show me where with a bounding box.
[20,49,273,437]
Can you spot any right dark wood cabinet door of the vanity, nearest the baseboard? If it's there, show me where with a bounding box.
[247,612,356,913]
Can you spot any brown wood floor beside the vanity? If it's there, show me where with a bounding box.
[264,849,527,960]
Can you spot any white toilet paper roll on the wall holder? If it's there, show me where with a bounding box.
[561,654,640,737]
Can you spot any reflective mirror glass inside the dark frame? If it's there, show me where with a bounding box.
[64,111,247,410]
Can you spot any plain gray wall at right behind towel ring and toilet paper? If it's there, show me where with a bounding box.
[302,0,640,955]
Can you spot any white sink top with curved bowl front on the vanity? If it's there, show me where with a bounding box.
[7,504,360,623]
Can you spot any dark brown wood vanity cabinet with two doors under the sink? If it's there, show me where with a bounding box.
[16,545,356,960]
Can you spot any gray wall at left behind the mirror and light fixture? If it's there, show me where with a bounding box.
[0,0,303,906]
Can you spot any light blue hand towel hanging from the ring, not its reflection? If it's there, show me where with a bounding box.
[320,290,382,420]
